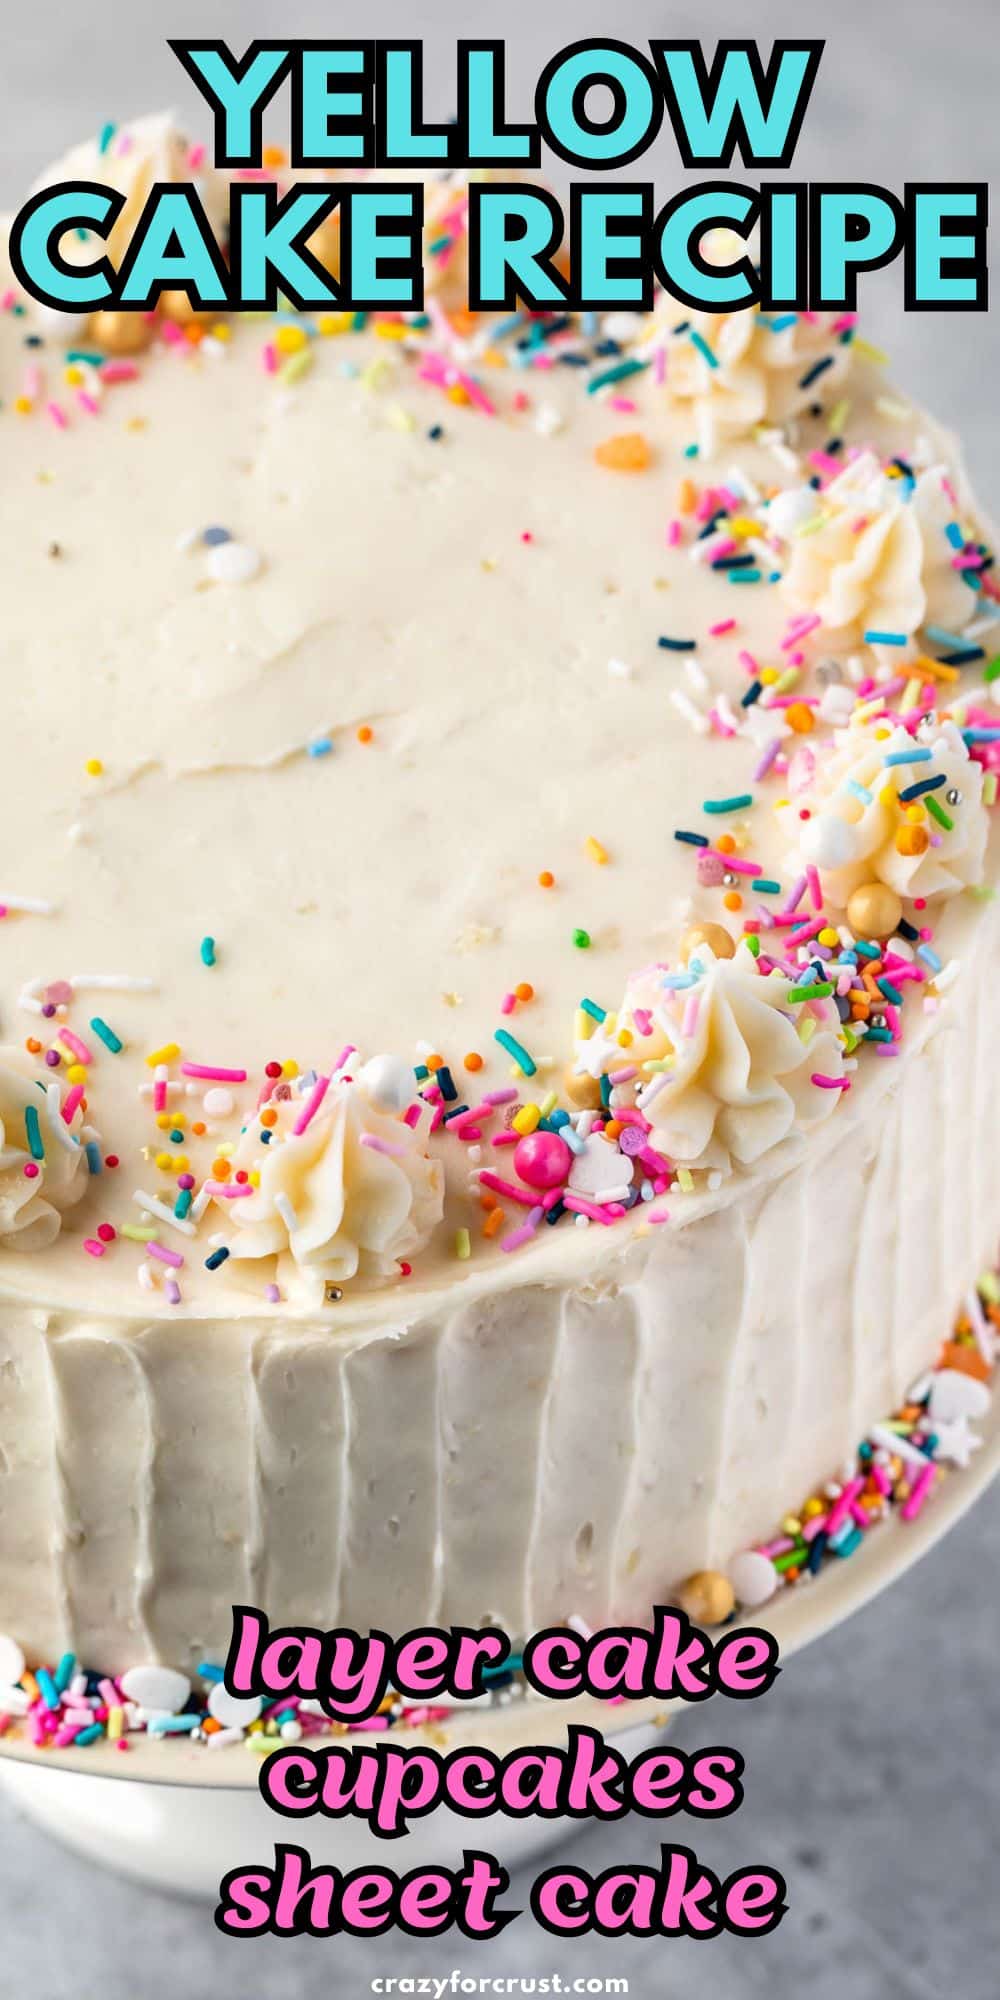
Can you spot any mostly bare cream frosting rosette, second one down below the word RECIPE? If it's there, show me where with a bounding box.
[768,452,974,640]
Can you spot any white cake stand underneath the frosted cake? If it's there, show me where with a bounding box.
[0,1406,1000,1900]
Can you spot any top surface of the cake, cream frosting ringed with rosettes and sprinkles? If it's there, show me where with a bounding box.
[0,124,994,1310]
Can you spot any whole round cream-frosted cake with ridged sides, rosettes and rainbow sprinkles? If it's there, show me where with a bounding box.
[0,120,1000,1706]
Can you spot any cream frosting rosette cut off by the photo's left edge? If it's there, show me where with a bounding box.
[0,1048,88,1250]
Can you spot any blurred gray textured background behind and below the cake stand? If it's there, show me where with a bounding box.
[0,0,1000,2000]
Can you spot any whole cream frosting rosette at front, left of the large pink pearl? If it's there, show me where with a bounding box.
[214,1078,444,1298]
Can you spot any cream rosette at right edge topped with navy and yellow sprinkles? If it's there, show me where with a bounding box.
[778,718,988,908]
